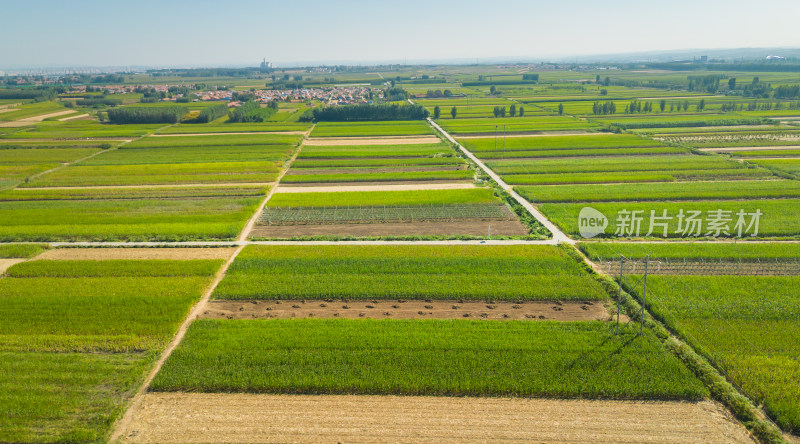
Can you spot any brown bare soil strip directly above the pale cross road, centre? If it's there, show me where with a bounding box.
[250,219,528,238]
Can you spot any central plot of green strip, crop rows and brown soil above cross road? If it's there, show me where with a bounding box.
[251,185,542,238]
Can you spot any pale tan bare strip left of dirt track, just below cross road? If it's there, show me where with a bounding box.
[35,247,236,261]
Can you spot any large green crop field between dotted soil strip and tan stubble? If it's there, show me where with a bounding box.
[152,319,707,399]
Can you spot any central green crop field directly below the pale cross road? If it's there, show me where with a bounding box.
[214,246,606,301]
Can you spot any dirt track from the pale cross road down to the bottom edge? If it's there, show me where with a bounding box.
[109,245,244,442]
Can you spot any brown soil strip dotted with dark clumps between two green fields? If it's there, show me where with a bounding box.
[201,299,611,321]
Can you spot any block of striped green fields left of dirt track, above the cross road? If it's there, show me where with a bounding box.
[0,126,302,242]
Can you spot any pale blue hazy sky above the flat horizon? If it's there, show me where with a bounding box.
[0,0,800,68]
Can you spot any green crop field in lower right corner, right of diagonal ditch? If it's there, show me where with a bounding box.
[624,276,800,433]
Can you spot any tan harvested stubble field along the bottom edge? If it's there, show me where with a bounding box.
[123,393,755,443]
